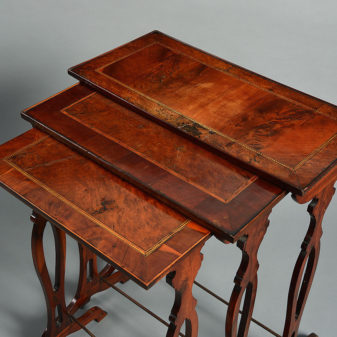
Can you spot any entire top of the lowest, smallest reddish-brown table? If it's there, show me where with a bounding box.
[0,129,209,288]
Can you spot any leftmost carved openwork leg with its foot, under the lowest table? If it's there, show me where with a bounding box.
[31,212,106,337]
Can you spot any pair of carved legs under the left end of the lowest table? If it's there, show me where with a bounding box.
[31,212,127,337]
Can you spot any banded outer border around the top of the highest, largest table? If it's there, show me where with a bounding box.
[68,31,337,195]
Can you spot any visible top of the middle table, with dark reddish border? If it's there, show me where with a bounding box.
[22,85,283,241]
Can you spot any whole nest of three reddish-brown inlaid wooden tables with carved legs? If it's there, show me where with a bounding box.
[0,31,337,337]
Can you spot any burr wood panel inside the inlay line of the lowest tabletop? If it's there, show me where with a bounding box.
[5,137,188,255]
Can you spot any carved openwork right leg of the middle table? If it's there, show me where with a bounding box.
[226,213,269,337]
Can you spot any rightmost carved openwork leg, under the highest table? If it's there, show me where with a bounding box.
[283,184,335,337]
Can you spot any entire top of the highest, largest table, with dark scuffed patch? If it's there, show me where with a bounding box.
[69,31,337,194]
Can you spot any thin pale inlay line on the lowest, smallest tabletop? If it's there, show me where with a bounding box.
[3,148,191,256]
